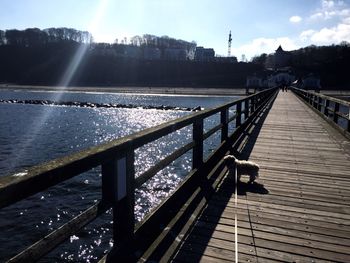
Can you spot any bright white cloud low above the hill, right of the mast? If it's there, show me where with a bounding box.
[232,37,299,59]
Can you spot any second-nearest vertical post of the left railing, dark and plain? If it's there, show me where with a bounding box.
[192,118,203,169]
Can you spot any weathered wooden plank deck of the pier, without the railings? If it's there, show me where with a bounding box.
[173,92,350,262]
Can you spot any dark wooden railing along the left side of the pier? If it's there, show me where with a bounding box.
[0,89,276,262]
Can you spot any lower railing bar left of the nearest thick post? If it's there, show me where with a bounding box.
[8,202,110,262]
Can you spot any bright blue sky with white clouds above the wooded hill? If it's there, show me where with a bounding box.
[0,0,350,60]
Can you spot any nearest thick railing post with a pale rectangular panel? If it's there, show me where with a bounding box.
[102,149,135,257]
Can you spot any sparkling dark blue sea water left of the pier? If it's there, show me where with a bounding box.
[0,91,235,262]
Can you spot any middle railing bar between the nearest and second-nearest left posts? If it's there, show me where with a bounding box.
[135,142,194,188]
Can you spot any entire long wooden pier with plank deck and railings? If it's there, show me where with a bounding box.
[0,89,350,262]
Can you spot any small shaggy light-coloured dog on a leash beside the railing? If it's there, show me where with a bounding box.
[224,155,259,183]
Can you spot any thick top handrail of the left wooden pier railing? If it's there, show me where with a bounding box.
[0,90,276,208]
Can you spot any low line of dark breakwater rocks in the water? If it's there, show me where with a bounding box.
[0,99,202,111]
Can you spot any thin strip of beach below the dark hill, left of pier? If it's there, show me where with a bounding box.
[0,84,245,96]
